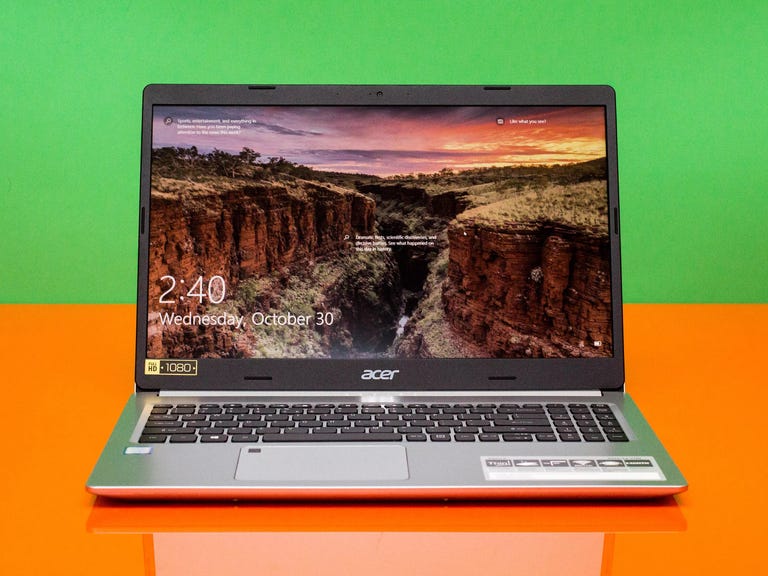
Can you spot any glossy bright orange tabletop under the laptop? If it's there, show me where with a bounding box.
[0,304,768,576]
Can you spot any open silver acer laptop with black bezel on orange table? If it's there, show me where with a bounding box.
[87,85,687,499]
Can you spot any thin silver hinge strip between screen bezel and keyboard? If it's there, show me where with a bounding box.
[158,390,603,402]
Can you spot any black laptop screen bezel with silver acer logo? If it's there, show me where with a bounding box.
[136,85,624,393]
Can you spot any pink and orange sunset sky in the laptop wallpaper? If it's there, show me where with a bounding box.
[152,106,606,176]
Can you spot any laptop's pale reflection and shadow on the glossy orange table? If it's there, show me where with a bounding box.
[87,497,686,576]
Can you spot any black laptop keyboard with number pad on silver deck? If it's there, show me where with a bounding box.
[139,403,628,444]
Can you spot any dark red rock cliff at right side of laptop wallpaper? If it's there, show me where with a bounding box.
[442,220,612,357]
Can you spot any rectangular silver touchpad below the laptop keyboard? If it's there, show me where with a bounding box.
[235,445,408,482]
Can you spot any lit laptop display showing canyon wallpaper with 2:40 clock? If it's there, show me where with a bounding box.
[147,106,613,359]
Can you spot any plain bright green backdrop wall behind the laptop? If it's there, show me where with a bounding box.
[0,0,768,303]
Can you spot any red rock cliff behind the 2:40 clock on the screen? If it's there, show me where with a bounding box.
[148,178,375,357]
